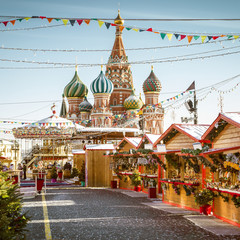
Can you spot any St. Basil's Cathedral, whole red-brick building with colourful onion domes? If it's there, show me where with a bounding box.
[60,13,164,134]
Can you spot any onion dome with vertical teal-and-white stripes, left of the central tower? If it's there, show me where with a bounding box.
[90,69,113,94]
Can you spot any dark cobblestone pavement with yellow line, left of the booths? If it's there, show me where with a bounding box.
[23,188,240,240]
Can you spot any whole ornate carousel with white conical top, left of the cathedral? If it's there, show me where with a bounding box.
[12,104,76,181]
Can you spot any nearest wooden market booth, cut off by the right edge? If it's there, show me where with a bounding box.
[202,112,240,227]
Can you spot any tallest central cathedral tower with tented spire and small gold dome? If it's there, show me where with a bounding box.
[105,11,133,114]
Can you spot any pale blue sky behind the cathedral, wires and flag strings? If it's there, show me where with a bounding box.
[0,0,240,137]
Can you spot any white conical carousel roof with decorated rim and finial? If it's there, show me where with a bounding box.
[12,105,76,138]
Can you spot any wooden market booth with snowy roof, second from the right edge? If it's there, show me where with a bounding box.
[155,124,209,211]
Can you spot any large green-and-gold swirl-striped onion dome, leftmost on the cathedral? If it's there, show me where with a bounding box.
[63,66,88,98]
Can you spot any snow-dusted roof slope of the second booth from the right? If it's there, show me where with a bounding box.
[175,124,210,140]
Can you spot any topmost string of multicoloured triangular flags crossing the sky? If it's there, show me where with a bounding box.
[0,16,240,43]
